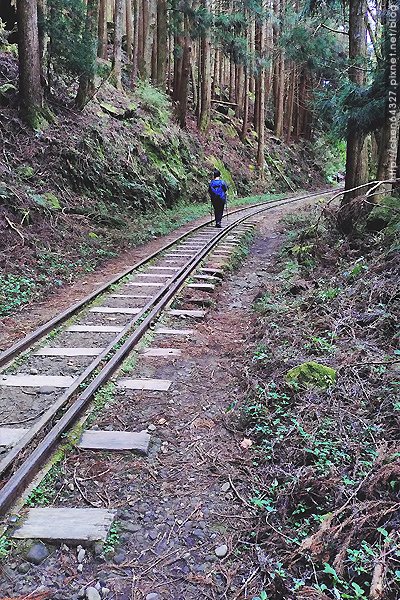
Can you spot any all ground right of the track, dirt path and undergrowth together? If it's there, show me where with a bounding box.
[0,195,400,600]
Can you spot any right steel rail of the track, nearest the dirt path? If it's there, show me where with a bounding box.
[0,191,340,515]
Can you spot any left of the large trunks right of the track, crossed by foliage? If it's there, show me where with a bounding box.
[341,0,367,204]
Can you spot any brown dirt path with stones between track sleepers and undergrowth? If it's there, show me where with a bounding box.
[0,202,318,600]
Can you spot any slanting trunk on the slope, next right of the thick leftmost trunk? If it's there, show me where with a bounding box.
[75,0,99,110]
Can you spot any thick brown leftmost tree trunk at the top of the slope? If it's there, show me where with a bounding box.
[17,0,43,129]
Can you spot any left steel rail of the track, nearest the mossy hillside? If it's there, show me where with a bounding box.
[0,190,338,368]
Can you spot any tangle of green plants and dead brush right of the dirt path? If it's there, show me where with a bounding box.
[240,201,400,600]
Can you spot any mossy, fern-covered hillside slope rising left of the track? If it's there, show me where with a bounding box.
[0,46,323,315]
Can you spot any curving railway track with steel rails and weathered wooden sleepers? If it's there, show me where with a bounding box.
[0,186,338,536]
